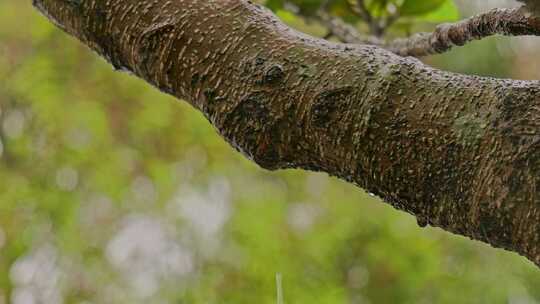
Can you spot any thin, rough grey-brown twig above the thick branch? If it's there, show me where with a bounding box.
[317,7,540,57]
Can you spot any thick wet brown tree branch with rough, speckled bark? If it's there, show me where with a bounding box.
[34,0,540,265]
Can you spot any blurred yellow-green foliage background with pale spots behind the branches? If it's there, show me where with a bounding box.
[0,0,540,304]
